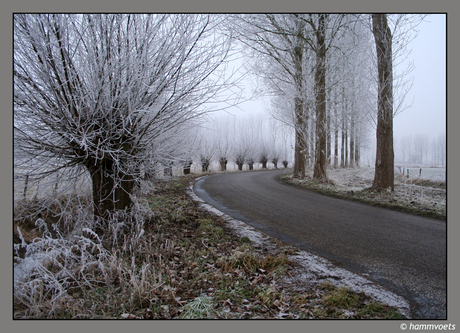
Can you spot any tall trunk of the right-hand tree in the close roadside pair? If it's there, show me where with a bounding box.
[313,14,327,181]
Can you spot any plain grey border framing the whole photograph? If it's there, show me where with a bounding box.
[0,0,454,332]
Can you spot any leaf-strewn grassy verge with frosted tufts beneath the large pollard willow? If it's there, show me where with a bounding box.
[13,172,408,319]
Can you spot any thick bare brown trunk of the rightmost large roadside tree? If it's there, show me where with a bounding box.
[371,14,394,191]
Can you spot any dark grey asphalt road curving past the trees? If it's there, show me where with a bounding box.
[194,170,447,319]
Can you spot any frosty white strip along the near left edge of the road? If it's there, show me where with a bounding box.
[188,180,410,318]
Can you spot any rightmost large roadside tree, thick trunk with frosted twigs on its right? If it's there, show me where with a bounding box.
[364,14,424,191]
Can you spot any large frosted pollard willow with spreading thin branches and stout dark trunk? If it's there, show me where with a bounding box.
[13,14,237,223]
